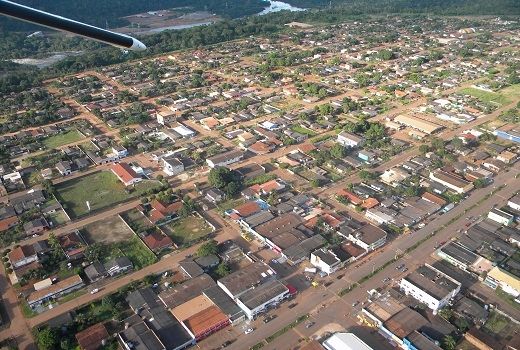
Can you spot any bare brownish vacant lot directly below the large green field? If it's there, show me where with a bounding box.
[82,215,134,245]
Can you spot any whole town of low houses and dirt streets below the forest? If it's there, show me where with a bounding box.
[0,9,520,350]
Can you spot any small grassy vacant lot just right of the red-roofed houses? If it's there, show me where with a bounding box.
[163,216,212,246]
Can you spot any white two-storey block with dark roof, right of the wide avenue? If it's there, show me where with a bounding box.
[399,264,461,314]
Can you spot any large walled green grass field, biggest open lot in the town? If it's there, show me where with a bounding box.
[56,171,159,218]
